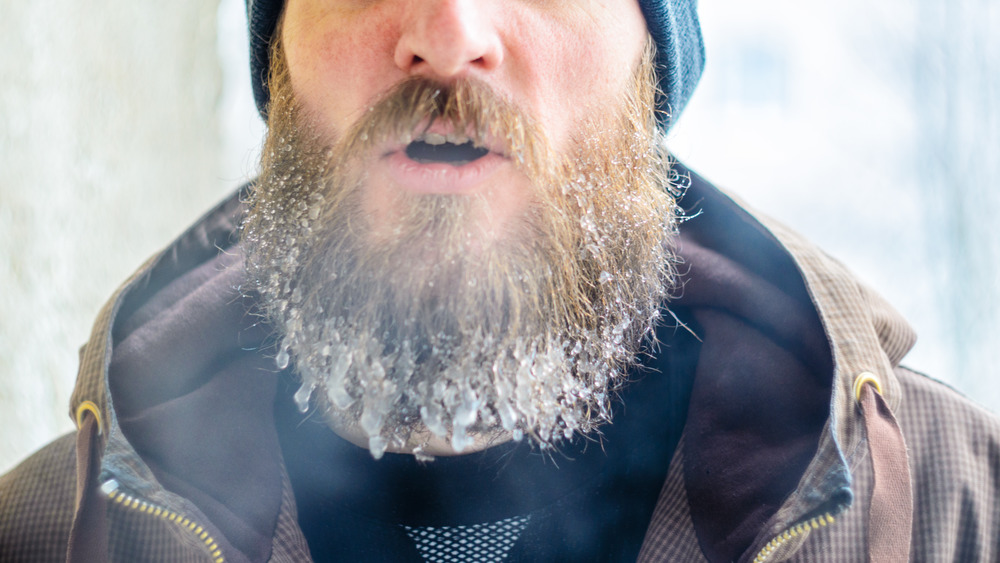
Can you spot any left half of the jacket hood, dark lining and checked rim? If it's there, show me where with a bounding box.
[66,189,292,561]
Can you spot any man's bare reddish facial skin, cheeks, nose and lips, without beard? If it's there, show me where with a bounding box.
[282,0,646,237]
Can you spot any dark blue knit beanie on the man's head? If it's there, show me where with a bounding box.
[247,0,705,130]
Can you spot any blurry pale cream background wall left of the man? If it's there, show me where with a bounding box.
[0,0,243,471]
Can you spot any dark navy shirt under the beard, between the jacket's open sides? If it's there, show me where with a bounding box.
[276,310,698,563]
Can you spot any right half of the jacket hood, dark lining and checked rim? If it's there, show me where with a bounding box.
[672,167,915,561]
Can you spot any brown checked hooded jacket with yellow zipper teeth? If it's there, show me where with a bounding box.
[0,165,1000,562]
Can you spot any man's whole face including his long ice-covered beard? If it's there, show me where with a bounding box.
[243,0,674,457]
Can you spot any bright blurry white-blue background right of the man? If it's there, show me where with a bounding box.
[670,0,1000,412]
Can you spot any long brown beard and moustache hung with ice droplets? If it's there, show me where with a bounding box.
[241,42,676,460]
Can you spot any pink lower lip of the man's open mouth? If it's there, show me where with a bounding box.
[386,151,507,194]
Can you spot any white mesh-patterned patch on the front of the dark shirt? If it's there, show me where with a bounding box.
[403,516,531,563]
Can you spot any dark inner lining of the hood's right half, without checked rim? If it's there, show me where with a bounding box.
[674,168,833,561]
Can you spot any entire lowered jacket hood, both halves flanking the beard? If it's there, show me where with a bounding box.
[71,164,914,561]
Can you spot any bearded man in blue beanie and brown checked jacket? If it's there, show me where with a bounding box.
[0,0,1000,563]
